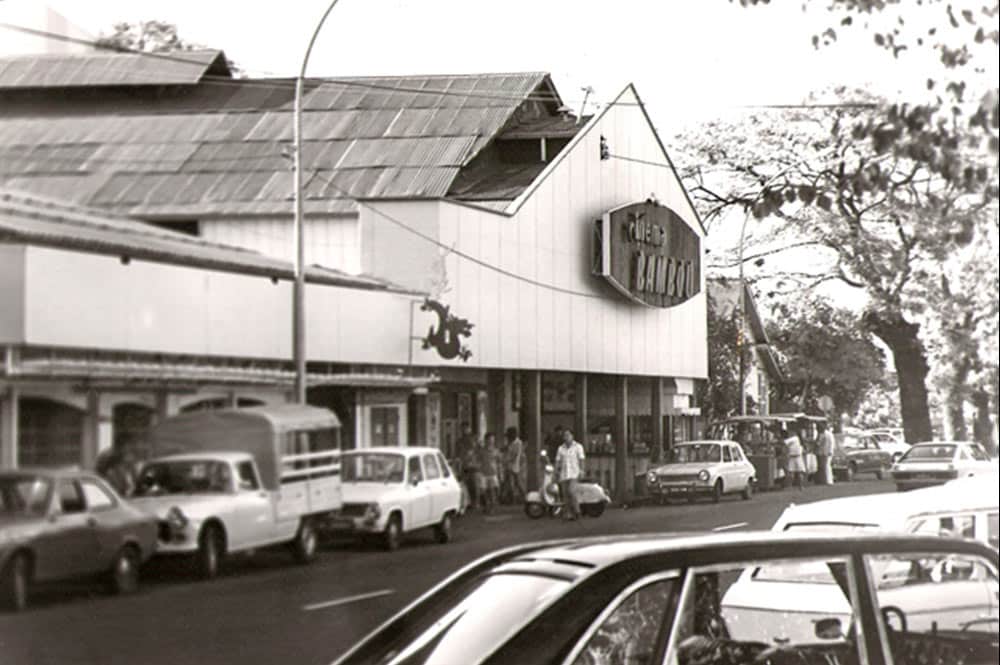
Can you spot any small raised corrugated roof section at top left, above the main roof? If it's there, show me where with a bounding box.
[0,50,229,89]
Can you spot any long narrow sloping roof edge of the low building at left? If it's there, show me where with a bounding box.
[0,188,412,293]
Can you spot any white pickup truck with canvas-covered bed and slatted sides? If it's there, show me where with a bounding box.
[133,404,342,578]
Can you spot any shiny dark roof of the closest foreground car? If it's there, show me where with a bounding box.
[496,531,996,572]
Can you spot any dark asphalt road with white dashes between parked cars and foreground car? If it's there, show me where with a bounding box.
[0,480,894,665]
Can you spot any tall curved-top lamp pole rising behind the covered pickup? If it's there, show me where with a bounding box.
[292,0,339,404]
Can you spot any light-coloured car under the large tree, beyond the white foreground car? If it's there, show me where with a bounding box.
[892,441,996,490]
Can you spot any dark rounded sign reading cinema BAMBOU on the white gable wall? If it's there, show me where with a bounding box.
[593,202,701,307]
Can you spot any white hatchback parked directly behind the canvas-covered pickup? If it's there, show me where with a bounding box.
[326,446,462,551]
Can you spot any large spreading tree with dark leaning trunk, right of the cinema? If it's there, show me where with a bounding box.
[681,91,997,441]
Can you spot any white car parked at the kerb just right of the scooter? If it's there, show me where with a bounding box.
[646,441,755,503]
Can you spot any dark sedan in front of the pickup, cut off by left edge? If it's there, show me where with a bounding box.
[0,469,156,611]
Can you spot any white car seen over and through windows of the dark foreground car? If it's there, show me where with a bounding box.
[722,475,1000,643]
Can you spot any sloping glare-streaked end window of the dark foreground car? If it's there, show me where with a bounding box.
[345,574,570,665]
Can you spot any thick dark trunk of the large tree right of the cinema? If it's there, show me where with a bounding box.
[864,312,934,443]
